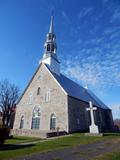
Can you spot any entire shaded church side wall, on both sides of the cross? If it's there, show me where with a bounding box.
[68,97,113,132]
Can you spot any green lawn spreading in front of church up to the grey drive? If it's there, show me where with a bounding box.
[0,133,119,160]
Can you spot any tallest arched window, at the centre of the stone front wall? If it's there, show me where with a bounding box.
[31,106,41,129]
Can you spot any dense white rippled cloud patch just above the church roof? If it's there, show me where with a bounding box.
[62,53,120,88]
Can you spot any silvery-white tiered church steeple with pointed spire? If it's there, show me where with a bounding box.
[42,16,60,75]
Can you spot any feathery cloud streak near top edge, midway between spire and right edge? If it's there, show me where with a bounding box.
[78,7,94,19]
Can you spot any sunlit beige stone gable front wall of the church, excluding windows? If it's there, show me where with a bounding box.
[14,64,68,136]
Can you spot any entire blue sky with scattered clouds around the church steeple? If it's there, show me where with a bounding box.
[0,0,120,118]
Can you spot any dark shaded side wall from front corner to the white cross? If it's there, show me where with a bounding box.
[68,96,90,132]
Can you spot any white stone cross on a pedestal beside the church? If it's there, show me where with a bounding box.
[86,101,99,134]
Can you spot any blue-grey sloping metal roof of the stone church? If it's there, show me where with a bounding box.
[47,66,109,109]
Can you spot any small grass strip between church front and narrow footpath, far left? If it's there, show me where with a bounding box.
[5,136,41,144]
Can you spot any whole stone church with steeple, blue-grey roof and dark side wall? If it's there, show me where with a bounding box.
[12,17,113,137]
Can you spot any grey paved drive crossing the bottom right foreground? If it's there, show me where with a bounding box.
[13,137,120,160]
